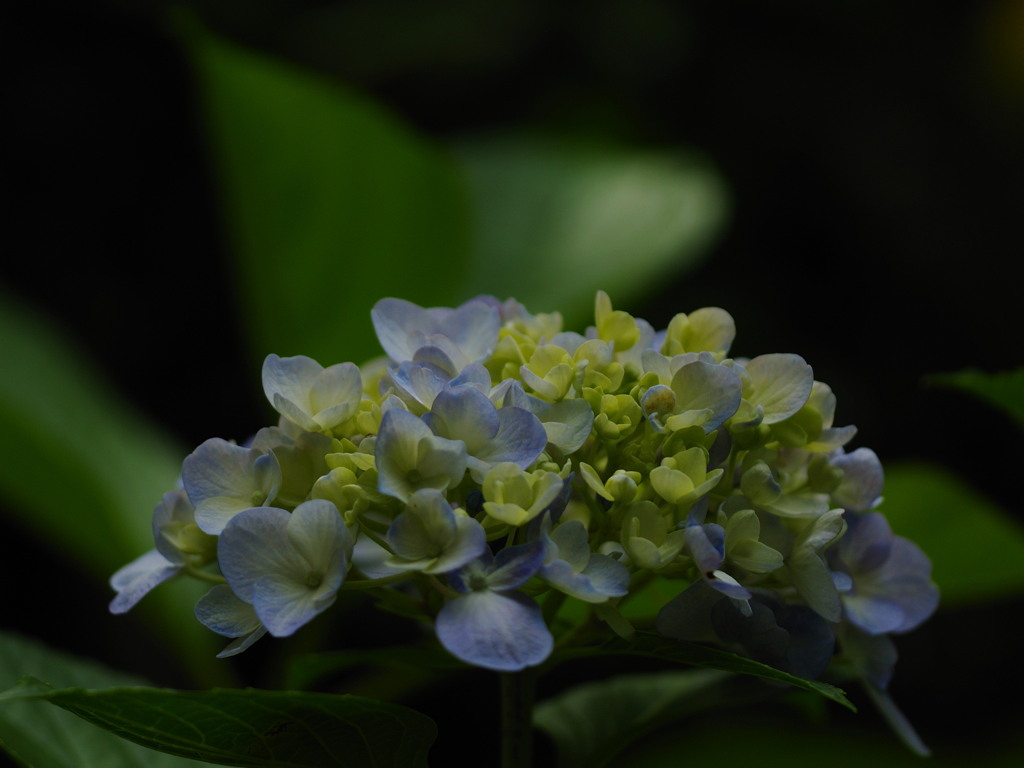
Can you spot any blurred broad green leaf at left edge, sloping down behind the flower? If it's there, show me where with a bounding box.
[0,293,216,670]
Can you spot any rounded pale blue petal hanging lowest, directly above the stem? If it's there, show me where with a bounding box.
[435,591,554,672]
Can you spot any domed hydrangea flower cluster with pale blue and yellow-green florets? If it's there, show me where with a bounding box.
[111,293,938,690]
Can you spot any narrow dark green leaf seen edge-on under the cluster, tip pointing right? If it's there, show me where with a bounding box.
[554,632,856,711]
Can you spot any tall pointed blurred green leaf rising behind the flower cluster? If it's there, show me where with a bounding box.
[180,17,469,365]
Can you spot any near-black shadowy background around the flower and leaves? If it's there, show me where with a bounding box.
[0,0,1024,765]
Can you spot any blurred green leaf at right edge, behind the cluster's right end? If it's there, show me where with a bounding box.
[882,463,1024,606]
